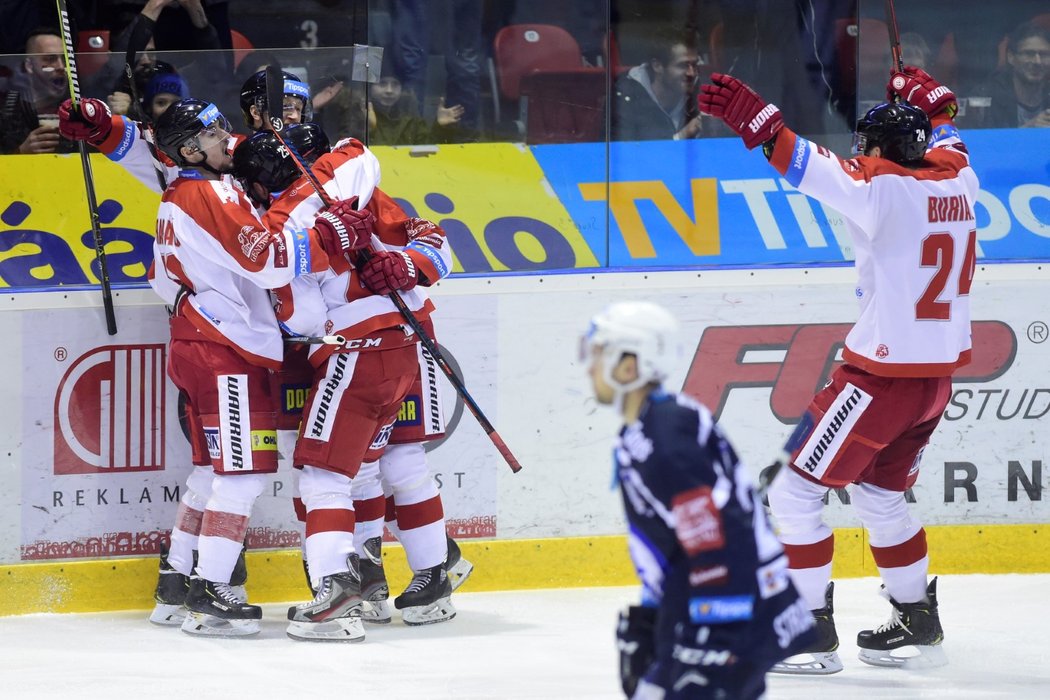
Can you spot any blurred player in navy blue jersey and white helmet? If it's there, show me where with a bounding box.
[581,302,815,700]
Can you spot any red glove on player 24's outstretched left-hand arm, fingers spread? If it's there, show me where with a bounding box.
[696,72,784,150]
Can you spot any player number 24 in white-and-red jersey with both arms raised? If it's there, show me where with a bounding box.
[699,66,978,674]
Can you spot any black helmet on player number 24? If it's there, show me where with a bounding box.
[854,102,932,164]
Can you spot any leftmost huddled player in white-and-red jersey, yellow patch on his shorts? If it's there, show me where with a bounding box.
[145,99,363,636]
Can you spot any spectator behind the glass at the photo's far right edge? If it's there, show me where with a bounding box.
[983,22,1050,128]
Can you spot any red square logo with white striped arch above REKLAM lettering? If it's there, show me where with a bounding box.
[54,344,165,475]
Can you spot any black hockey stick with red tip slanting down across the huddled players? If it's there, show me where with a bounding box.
[266,64,522,472]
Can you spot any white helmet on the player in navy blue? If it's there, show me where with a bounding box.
[581,301,679,393]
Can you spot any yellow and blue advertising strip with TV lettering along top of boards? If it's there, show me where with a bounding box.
[0,129,1050,288]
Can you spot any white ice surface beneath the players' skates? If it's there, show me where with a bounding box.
[0,575,1050,700]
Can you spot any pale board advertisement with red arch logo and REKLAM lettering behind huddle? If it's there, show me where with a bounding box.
[11,295,499,560]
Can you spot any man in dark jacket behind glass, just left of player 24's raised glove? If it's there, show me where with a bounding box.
[612,29,700,141]
